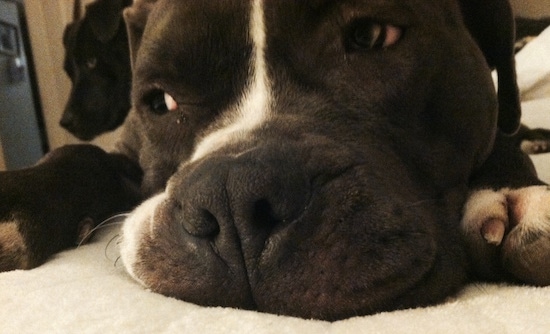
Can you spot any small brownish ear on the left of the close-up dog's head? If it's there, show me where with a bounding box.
[123,0,157,68]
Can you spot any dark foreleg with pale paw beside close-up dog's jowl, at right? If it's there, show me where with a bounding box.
[462,132,550,285]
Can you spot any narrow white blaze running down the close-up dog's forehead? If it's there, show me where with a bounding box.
[191,0,271,161]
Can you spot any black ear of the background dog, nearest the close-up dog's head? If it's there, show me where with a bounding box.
[86,0,128,43]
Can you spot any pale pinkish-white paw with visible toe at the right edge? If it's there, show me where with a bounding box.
[462,186,550,285]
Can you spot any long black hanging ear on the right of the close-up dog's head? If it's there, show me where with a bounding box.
[460,0,521,134]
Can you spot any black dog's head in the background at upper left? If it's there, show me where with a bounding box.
[60,0,132,140]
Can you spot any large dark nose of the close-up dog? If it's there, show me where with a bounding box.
[168,150,310,242]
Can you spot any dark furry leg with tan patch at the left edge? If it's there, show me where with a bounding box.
[0,145,141,271]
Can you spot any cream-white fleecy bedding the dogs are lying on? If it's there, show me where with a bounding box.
[0,29,550,334]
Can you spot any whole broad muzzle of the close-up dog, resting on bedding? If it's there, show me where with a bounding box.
[121,140,464,319]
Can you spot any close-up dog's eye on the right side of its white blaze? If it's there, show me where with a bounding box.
[346,19,403,51]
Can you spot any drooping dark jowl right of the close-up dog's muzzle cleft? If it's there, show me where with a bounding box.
[251,171,444,320]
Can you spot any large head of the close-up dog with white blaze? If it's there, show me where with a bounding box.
[121,0,519,319]
